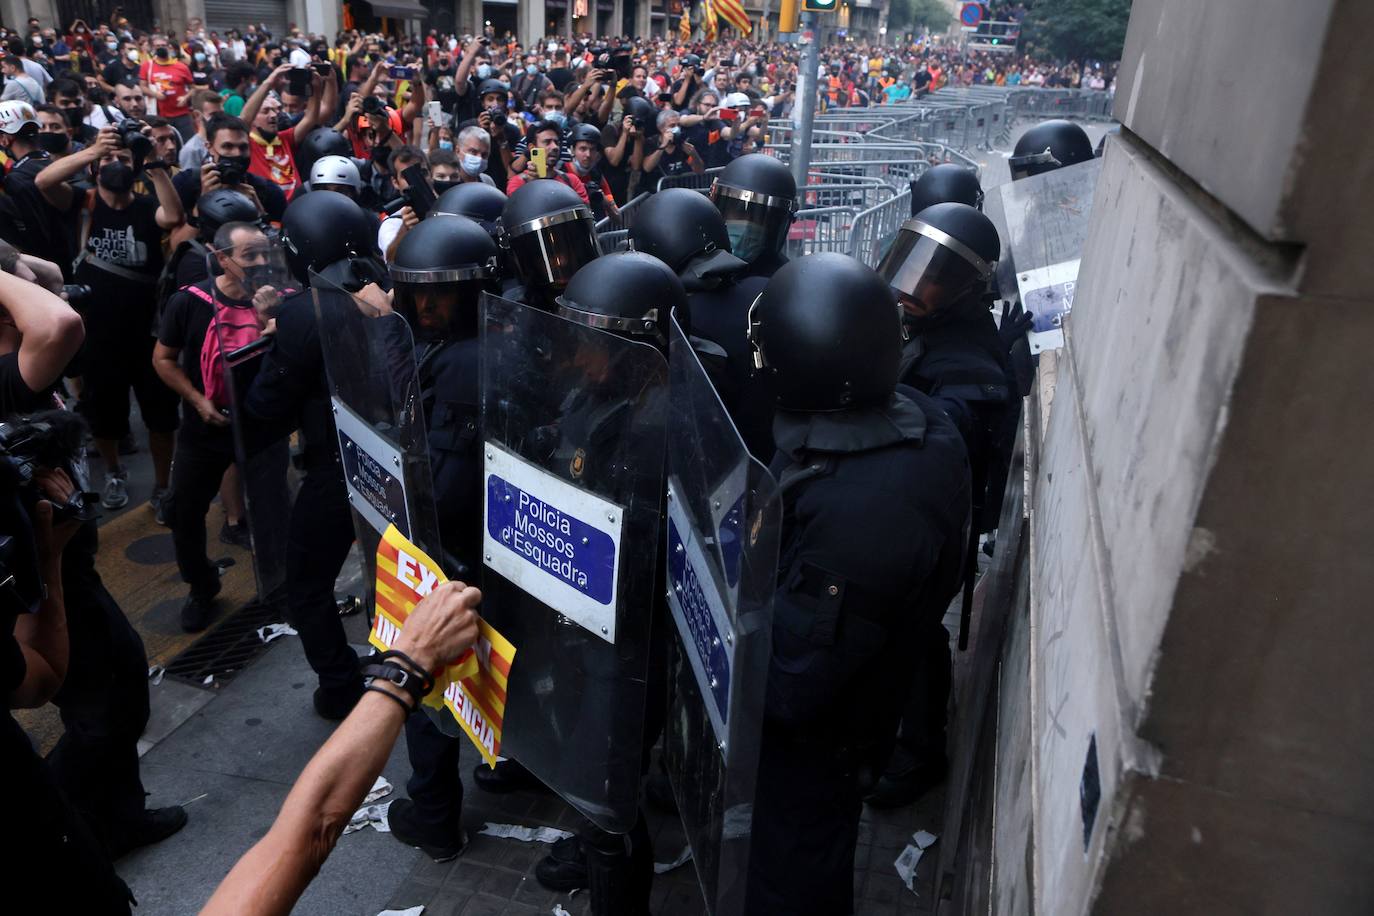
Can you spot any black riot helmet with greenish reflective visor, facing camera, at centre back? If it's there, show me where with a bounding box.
[710,152,797,264]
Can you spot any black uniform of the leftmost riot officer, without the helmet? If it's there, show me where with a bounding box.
[243,290,361,694]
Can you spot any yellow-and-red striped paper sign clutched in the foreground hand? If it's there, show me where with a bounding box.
[367,525,515,766]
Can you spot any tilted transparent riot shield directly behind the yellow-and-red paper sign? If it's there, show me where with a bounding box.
[311,272,463,736]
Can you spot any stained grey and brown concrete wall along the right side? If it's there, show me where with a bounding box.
[993,0,1374,916]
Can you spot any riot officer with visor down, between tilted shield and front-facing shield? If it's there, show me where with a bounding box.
[389,212,505,861]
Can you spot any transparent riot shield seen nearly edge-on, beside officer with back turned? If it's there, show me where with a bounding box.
[664,311,785,916]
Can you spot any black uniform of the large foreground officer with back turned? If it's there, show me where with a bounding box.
[746,387,969,916]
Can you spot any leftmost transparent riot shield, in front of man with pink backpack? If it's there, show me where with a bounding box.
[201,240,301,610]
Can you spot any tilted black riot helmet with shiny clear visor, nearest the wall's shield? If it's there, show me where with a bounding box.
[878,203,1002,317]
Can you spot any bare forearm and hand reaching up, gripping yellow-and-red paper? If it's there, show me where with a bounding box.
[201,582,481,916]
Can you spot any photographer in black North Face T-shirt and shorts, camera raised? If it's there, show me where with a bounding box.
[37,121,184,509]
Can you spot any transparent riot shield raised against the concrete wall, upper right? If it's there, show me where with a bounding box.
[987,159,1102,353]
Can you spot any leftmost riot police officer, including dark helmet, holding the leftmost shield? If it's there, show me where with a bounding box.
[243,191,386,720]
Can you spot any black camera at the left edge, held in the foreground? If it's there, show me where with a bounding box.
[0,409,99,525]
